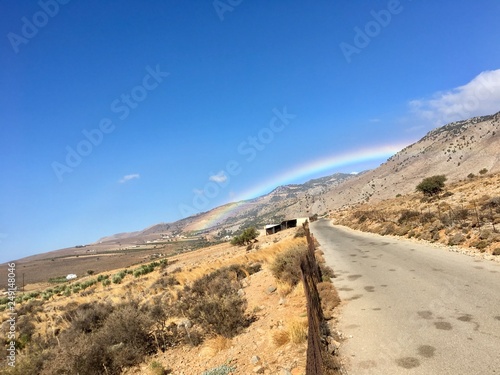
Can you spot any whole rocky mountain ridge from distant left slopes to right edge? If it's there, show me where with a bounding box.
[101,112,500,244]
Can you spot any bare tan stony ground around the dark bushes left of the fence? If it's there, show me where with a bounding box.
[2,229,307,375]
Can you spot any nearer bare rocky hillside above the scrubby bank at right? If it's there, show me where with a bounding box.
[312,112,500,212]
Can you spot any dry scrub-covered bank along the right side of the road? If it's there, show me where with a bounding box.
[332,173,500,257]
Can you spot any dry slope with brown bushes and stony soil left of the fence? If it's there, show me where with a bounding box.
[0,230,342,375]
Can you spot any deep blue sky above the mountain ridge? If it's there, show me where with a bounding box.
[0,0,500,261]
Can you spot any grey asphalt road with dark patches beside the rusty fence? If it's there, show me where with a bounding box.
[311,220,500,375]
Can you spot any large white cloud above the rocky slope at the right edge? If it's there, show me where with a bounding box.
[409,69,500,126]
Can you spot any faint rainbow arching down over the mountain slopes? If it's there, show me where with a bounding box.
[193,143,408,229]
